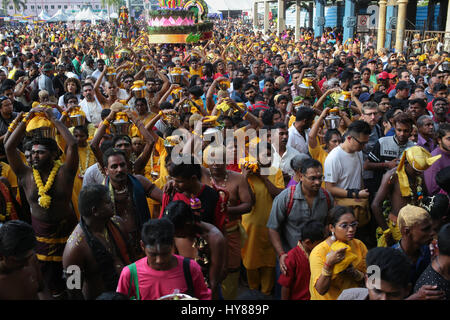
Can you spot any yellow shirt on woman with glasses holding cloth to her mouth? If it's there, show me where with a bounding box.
[309,239,367,300]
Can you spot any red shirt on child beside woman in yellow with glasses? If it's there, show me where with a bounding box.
[278,246,311,300]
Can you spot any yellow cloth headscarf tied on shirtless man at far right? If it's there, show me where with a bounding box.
[397,146,441,197]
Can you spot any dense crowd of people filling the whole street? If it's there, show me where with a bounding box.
[0,19,450,300]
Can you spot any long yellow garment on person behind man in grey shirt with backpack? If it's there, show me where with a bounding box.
[241,169,284,269]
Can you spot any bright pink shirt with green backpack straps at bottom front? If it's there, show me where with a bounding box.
[116,255,211,300]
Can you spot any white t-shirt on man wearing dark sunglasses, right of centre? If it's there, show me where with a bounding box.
[324,146,364,190]
